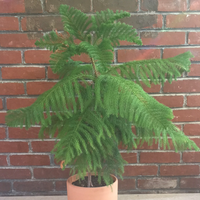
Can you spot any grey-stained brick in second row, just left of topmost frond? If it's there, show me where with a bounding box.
[21,16,63,31]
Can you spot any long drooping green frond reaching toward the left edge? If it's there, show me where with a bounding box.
[6,74,93,129]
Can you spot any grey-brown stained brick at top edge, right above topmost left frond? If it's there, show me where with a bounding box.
[45,0,91,13]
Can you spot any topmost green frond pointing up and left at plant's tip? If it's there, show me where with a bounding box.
[60,5,92,41]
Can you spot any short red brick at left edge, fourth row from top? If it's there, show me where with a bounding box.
[0,51,22,64]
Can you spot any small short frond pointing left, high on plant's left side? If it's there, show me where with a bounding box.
[35,31,66,52]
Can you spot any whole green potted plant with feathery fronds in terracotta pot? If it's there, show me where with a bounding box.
[6,5,198,200]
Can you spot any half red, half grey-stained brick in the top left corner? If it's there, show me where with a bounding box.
[0,0,42,13]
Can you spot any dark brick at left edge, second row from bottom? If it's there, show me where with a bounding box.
[0,169,31,180]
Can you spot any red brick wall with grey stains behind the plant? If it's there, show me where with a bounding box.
[0,0,200,195]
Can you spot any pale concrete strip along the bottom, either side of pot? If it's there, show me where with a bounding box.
[0,193,200,200]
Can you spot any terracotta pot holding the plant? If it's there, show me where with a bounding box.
[67,175,118,200]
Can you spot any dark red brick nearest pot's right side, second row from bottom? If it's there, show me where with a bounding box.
[123,165,158,176]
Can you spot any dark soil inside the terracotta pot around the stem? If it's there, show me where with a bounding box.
[72,176,113,187]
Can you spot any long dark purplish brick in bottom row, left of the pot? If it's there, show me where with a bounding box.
[13,181,54,192]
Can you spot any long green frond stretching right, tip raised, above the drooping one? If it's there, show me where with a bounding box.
[107,51,193,87]
